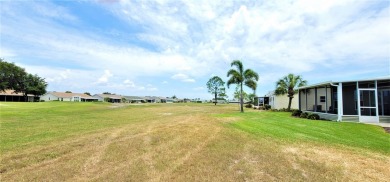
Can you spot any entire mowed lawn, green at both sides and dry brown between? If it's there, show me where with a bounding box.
[0,102,390,181]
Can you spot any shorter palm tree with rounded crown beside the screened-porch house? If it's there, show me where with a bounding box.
[275,73,307,110]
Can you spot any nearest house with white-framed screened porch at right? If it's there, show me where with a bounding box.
[298,76,390,123]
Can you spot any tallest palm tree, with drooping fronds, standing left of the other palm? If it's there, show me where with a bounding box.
[227,60,259,112]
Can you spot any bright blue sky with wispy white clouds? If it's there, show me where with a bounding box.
[0,0,390,99]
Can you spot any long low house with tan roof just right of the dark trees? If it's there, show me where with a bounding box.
[40,92,98,102]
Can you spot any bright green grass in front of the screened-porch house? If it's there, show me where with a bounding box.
[218,112,390,154]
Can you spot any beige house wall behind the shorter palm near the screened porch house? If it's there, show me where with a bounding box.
[265,92,299,109]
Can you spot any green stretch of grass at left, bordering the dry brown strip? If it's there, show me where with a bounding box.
[0,102,155,152]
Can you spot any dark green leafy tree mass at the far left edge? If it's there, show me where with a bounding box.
[0,58,47,97]
